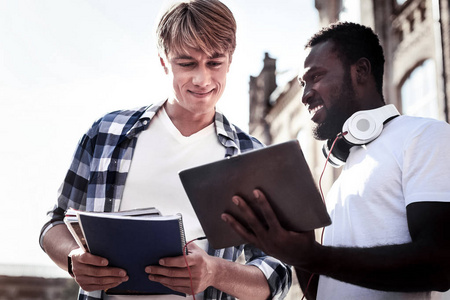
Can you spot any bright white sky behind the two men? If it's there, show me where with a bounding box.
[0,0,319,276]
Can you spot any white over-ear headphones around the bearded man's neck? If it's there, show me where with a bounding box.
[322,104,400,167]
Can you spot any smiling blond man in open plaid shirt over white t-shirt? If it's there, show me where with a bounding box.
[40,0,291,300]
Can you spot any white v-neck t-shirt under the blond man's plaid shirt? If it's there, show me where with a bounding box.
[106,108,225,300]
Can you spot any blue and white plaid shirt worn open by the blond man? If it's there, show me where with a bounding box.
[40,102,292,300]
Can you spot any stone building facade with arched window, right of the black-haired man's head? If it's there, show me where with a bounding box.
[378,0,450,122]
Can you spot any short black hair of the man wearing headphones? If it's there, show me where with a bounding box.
[305,22,385,97]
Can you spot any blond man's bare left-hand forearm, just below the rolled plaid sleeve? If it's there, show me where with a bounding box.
[43,224,78,271]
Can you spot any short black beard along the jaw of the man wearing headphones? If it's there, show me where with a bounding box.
[313,70,359,140]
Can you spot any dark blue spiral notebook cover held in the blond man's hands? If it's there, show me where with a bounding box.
[78,212,185,296]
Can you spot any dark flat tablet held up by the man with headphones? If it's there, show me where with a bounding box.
[179,140,331,249]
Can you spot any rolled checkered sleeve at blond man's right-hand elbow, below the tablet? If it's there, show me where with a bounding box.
[244,245,292,299]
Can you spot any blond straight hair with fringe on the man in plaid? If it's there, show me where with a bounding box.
[156,0,236,59]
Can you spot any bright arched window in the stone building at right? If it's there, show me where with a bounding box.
[400,59,439,119]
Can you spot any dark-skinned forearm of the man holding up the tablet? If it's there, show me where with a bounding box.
[306,243,449,292]
